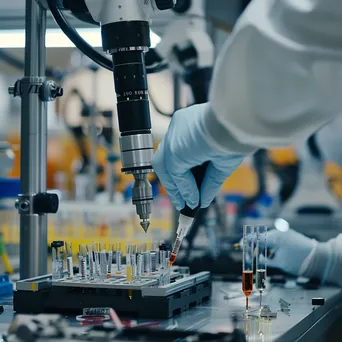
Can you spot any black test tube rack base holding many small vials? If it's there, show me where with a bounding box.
[13,267,212,319]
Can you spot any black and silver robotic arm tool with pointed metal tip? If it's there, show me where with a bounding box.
[58,0,175,232]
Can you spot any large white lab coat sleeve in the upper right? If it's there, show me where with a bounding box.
[205,0,342,151]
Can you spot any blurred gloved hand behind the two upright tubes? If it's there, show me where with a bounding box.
[267,229,317,276]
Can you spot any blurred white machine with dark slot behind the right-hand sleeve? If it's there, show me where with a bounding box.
[278,134,342,241]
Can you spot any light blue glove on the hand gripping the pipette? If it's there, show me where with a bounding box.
[152,104,244,210]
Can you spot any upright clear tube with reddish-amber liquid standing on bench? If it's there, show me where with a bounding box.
[242,225,255,314]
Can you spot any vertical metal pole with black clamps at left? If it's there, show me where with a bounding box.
[20,0,47,279]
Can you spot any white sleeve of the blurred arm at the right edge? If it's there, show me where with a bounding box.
[303,234,342,286]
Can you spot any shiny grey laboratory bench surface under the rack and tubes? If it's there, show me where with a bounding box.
[0,281,342,342]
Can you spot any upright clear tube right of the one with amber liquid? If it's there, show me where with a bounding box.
[255,225,267,309]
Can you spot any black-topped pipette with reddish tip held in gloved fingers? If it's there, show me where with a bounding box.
[170,162,209,266]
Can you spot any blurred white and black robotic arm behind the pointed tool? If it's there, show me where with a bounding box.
[147,0,215,104]
